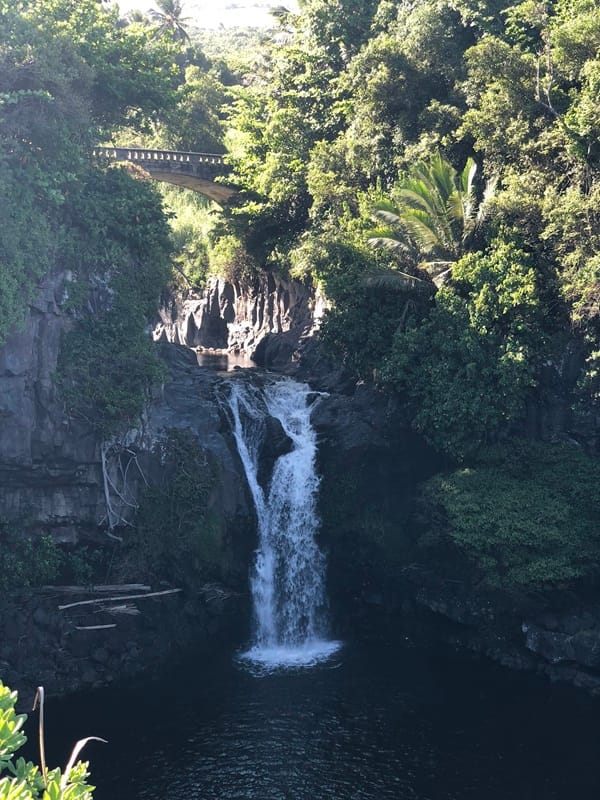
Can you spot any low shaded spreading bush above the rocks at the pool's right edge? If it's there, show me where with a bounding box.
[423,440,600,591]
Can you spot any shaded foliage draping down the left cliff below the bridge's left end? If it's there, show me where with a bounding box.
[58,169,171,436]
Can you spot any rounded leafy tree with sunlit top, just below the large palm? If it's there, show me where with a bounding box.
[381,240,544,458]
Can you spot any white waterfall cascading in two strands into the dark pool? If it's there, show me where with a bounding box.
[229,379,340,669]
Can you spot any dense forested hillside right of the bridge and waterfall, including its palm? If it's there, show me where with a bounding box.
[185,0,600,592]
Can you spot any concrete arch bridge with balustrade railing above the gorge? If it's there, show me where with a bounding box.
[93,147,236,205]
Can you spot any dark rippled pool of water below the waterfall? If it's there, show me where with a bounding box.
[47,639,600,800]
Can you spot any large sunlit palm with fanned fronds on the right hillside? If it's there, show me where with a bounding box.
[369,153,495,286]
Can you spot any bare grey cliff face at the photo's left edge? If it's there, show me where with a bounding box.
[0,273,102,540]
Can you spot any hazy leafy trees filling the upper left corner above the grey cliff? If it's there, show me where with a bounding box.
[0,0,176,342]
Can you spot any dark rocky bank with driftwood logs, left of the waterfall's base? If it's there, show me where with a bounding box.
[0,585,247,708]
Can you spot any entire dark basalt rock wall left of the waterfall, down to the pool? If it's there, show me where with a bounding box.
[0,275,255,694]
